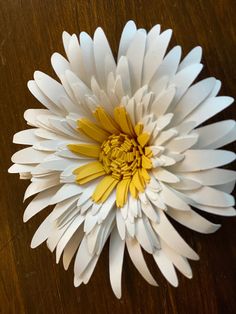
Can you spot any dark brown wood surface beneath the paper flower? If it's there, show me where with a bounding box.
[0,0,236,314]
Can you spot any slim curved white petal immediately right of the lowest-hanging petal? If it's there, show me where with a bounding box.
[126,238,158,286]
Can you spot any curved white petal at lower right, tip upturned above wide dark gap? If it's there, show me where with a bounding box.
[167,208,220,233]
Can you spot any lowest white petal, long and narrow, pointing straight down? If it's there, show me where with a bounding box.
[109,228,125,299]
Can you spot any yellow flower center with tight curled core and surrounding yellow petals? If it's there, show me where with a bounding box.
[68,106,152,207]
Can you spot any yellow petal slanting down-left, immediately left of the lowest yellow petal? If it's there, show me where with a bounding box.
[92,176,119,203]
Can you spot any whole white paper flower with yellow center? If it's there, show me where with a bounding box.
[9,21,236,298]
